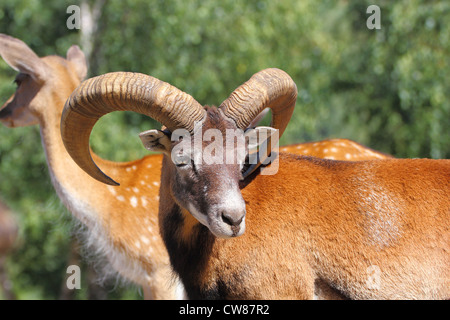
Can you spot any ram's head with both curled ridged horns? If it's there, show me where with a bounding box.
[61,69,297,237]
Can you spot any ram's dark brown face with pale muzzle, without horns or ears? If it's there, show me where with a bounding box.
[171,108,245,238]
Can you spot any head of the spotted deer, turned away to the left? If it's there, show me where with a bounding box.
[0,34,87,127]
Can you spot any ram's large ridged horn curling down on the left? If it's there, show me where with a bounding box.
[61,72,205,185]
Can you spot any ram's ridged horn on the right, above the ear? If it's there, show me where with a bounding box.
[220,68,297,137]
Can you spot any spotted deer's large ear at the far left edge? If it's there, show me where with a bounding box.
[0,33,48,82]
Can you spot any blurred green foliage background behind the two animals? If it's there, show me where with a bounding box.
[0,0,450,299]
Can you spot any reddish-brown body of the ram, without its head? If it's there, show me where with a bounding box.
[159,114,450,299]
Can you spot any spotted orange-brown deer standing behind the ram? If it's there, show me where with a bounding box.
[0,35,396,298]
